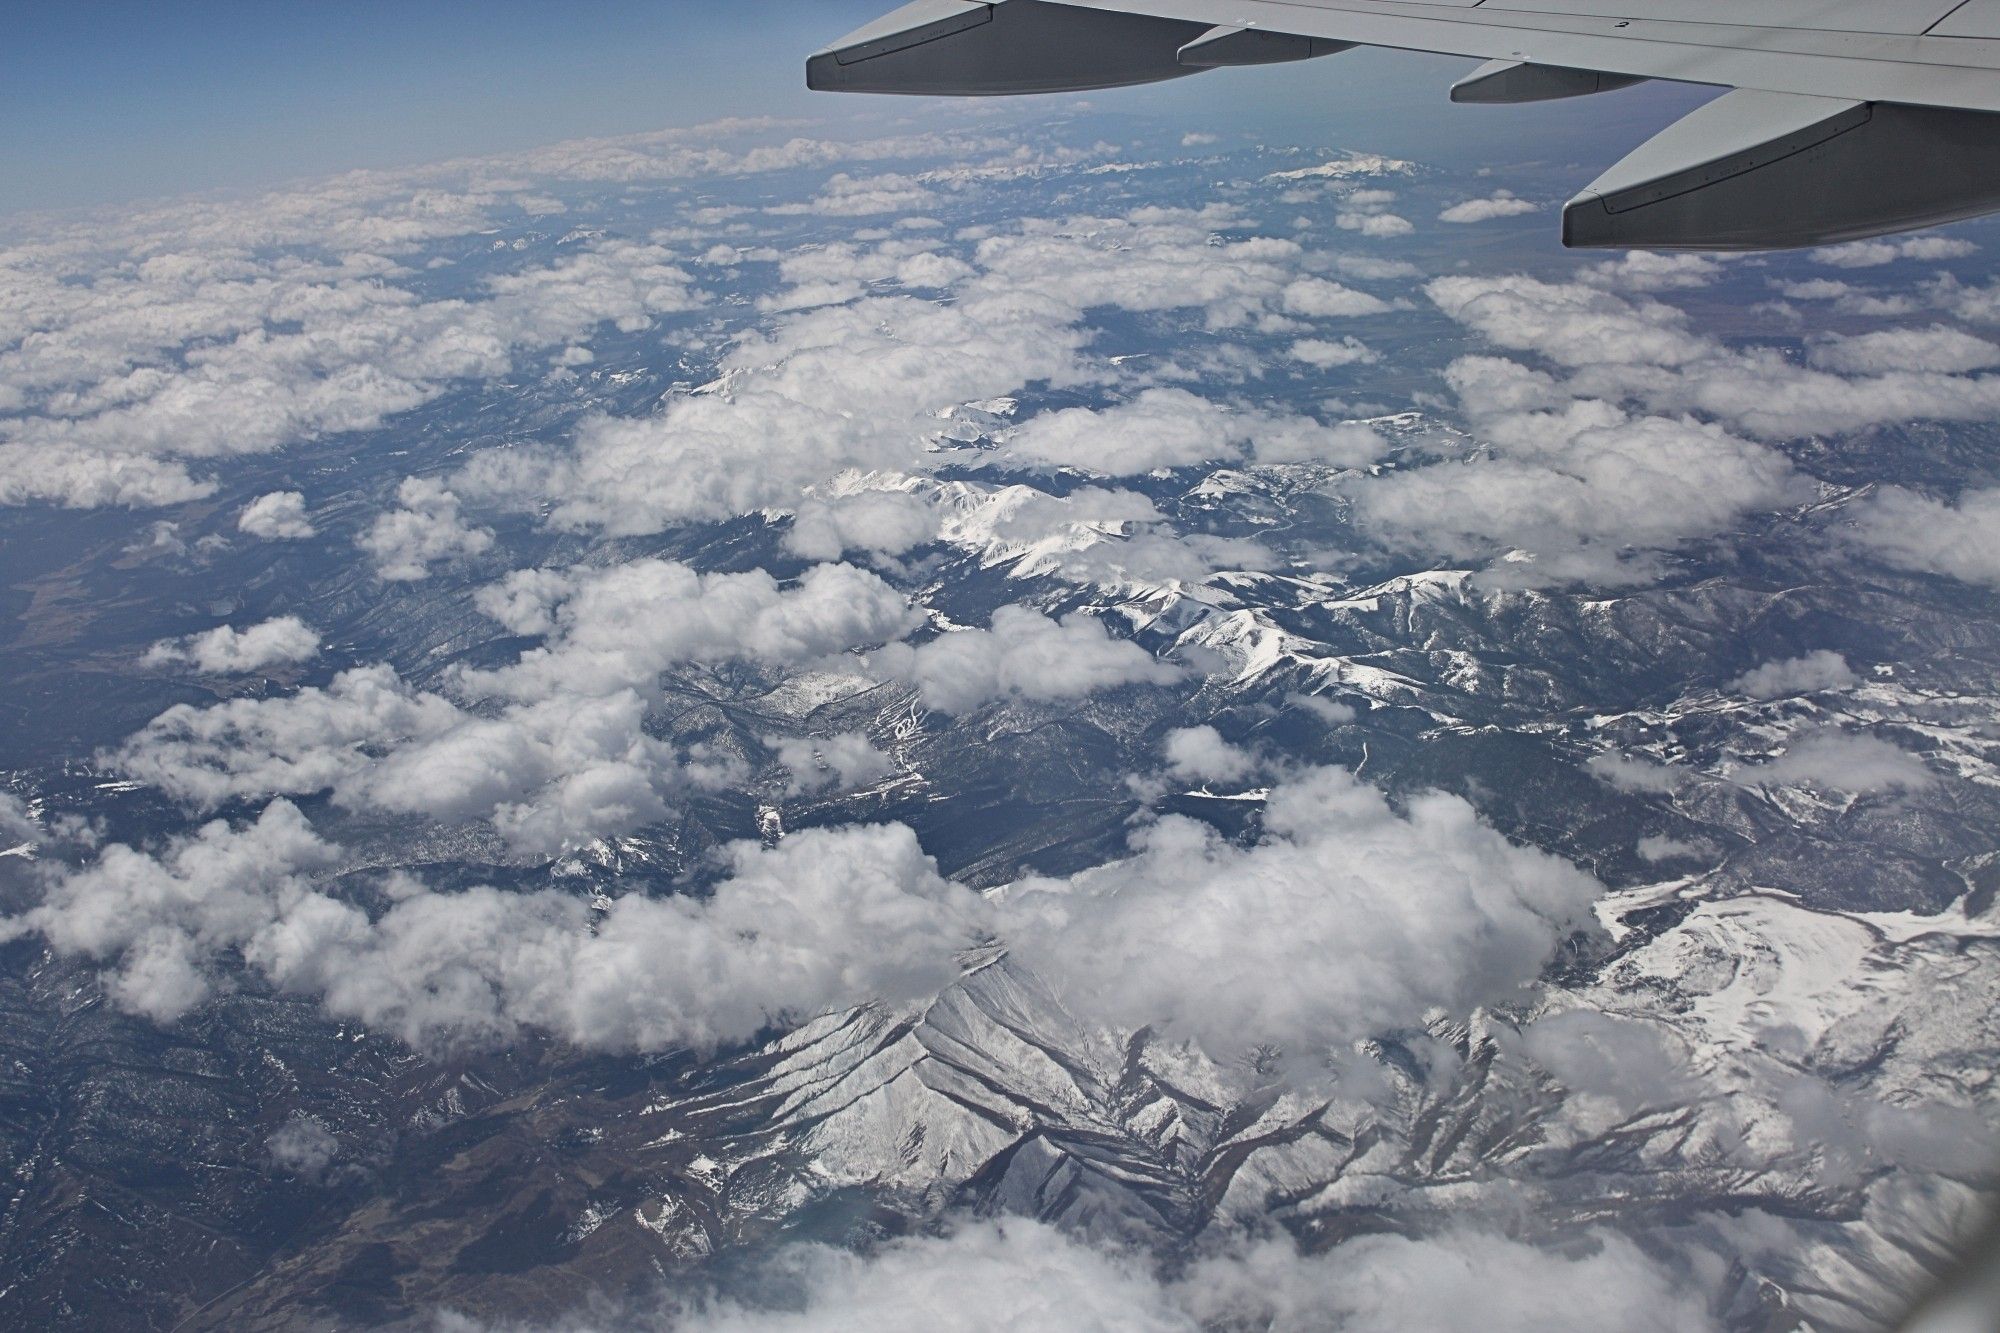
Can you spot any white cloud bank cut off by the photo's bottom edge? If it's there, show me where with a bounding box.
[438,1217,1718,1333]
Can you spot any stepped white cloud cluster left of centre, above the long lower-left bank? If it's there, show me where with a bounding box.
[117,560,912,857]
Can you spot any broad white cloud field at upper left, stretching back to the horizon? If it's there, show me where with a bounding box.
[0,111,1048,506]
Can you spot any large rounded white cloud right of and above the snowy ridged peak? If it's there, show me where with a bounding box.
[1002,769,1600,1059]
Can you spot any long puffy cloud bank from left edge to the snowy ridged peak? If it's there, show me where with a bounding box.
[6,801,980,1053]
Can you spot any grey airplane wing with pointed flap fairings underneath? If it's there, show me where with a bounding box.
[806,0,2000,250]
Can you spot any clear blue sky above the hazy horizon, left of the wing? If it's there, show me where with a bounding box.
[0,0,884,208]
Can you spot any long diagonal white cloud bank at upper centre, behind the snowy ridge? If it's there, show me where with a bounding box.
[452,208,1376,528]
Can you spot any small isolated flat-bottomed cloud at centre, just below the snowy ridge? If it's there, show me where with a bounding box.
[870,606,1182,713]
